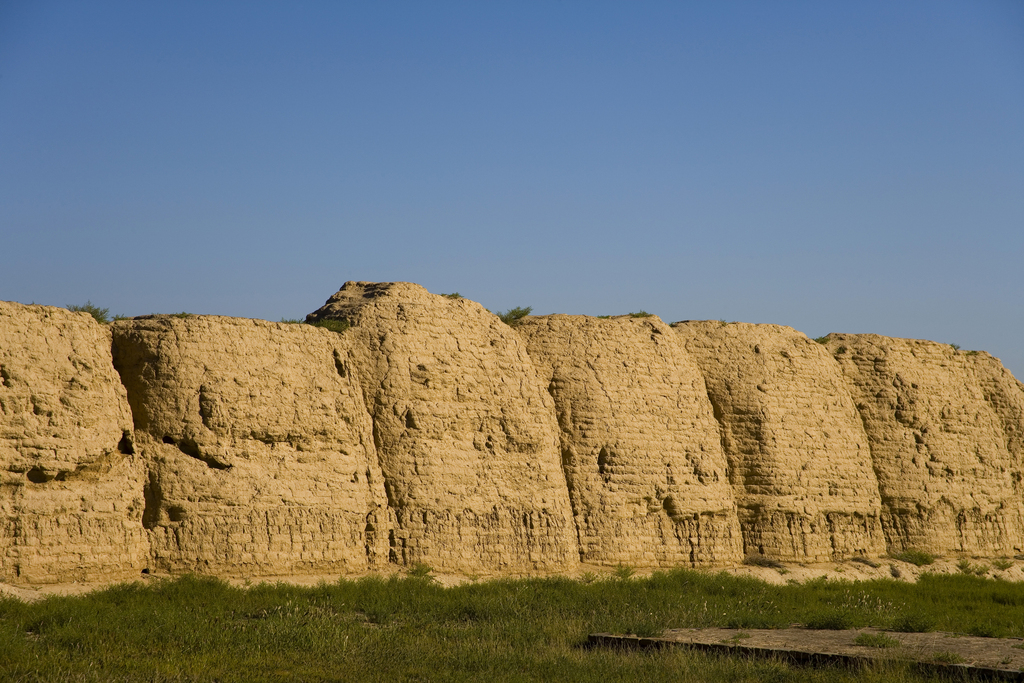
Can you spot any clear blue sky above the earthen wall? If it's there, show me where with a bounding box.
[0,0,1024,379]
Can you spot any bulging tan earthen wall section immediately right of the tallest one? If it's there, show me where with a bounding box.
[516,315,742,566]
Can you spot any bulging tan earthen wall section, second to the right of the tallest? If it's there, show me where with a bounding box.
[673,321,885,560]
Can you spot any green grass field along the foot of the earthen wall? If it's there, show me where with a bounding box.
[0,570,1024,683]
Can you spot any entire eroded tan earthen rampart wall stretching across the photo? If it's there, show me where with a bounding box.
[0,283,1024,584]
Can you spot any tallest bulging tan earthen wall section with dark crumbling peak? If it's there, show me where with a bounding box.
[307,283,579,572]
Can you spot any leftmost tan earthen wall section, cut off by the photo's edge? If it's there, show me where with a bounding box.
[0,302,148,583]
